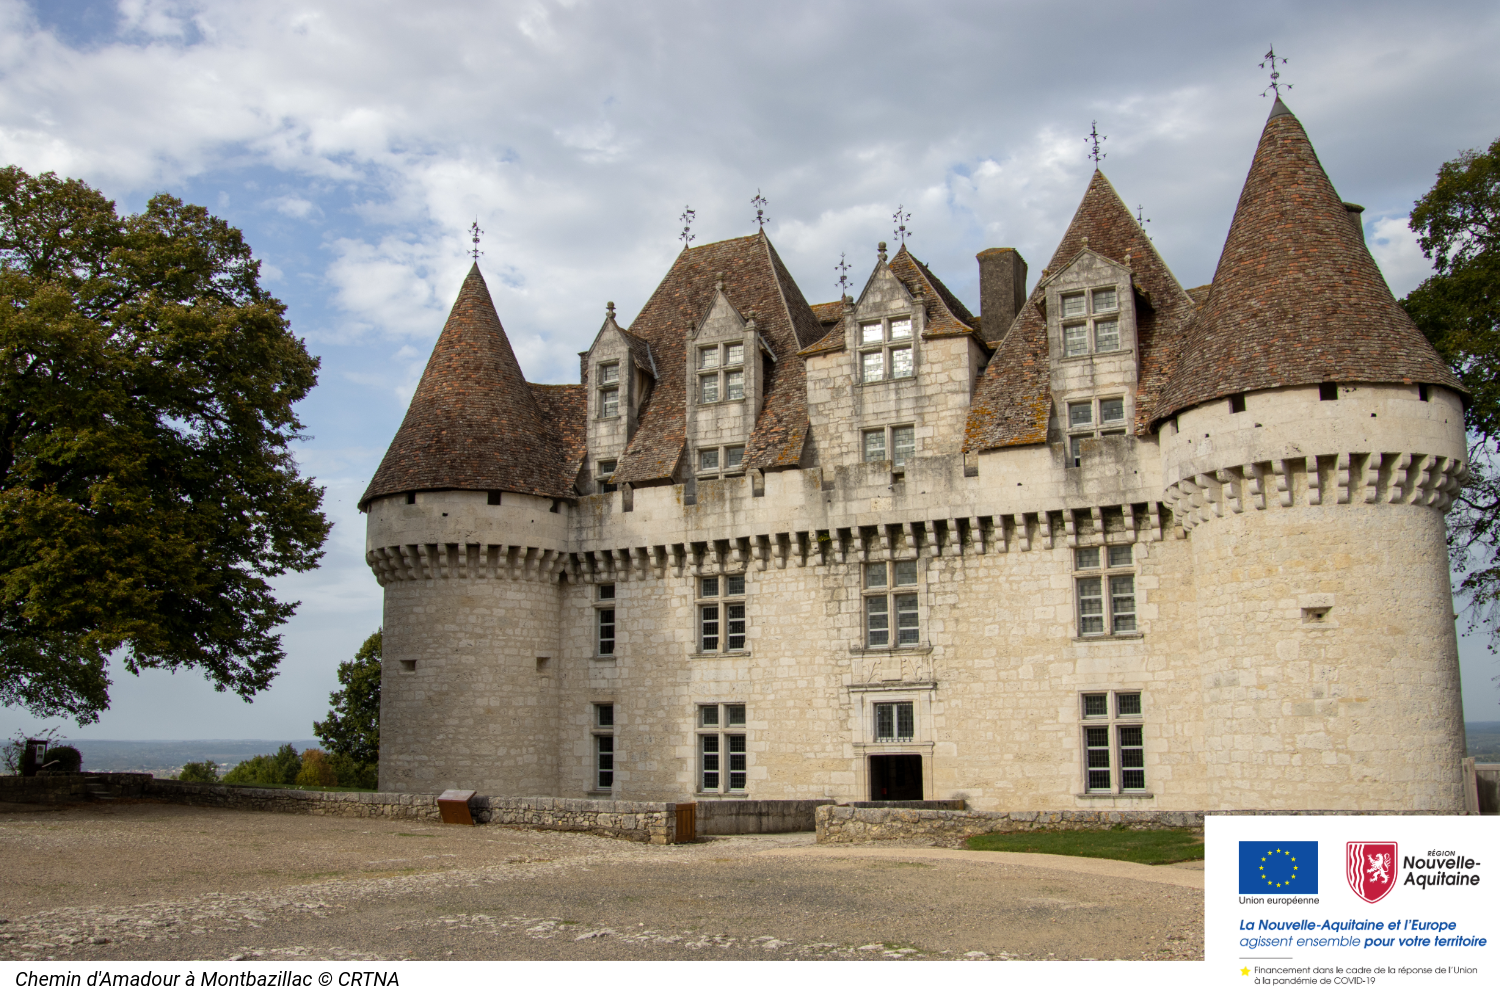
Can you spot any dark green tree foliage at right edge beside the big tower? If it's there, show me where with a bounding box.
[1401,139,1500,668]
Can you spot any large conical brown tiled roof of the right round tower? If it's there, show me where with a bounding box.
[1154,99,1466,420]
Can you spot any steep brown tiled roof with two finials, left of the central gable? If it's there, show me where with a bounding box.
[614,232,824,483]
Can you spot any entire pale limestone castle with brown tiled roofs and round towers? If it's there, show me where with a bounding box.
[360,99,1467,811]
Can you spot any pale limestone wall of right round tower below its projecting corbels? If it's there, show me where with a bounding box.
[1191,504,1464,811]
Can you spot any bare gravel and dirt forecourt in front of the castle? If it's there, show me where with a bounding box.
[0,804,1203,961]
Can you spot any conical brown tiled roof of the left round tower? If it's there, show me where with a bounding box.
[360,265,573,507]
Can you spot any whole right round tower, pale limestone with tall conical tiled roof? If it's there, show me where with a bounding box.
[1155,99,1467,811]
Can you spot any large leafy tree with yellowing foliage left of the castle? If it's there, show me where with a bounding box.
[0,166,329,724]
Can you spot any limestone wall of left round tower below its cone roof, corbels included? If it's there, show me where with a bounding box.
[369,492,567,795]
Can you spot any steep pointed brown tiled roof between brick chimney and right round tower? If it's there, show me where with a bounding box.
[965,171,1193,451]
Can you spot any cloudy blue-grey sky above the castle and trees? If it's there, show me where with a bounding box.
[0,0,1500,739]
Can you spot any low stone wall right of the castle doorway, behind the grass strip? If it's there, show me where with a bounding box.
[818,805,1203,846]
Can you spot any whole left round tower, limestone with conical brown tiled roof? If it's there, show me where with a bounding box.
[360,265,582,795]
